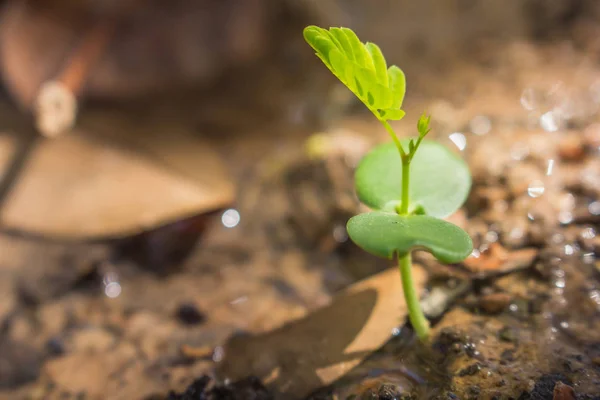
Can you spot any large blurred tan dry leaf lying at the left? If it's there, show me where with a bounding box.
[0,108,234,239]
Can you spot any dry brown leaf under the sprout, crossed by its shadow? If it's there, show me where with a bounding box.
[220,267,426,399]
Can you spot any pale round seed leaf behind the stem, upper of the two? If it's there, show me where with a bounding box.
[355,140,471,218]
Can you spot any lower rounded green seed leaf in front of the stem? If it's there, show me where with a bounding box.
[347,211,473,264]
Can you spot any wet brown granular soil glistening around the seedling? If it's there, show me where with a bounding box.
[0,21,600,400]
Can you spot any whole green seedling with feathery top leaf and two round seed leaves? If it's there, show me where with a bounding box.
[304,26,473,340]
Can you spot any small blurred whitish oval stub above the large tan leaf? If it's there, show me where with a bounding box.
[34,81,77,137]
